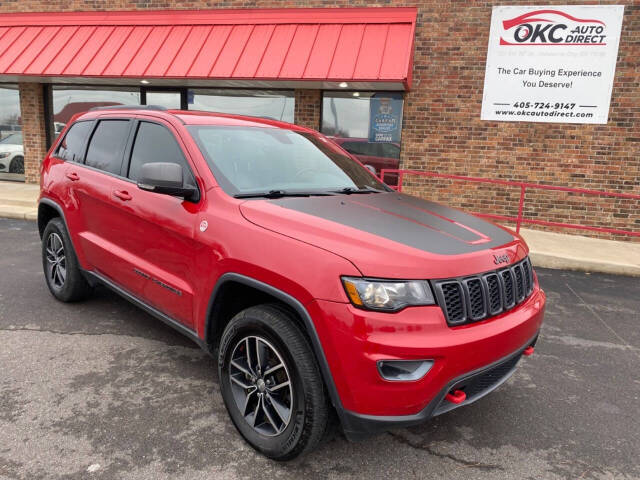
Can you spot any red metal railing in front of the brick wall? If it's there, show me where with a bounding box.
[380,169,640,237]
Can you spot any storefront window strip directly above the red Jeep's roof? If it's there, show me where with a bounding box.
[188,89,294,123]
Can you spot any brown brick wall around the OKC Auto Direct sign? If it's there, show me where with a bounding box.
[6,0,640,240]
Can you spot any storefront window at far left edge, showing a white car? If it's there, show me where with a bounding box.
[0,84,24,181]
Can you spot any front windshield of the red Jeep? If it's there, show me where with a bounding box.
[188,125,387,195]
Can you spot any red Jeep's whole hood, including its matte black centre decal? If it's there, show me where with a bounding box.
[240,193,527,278]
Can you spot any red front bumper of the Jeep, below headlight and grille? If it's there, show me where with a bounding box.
[307,282,546,438]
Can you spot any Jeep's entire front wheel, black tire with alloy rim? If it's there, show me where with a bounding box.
[218,305,330,461]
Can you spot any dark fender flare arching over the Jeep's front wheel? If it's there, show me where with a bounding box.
[204,272,345,420]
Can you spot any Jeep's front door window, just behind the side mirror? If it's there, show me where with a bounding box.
[129,122,195,185]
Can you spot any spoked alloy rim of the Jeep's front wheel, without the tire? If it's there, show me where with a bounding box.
[229,336,293,437]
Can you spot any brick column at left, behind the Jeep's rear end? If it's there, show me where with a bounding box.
[19,83,47,183]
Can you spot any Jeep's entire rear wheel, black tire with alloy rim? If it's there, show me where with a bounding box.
[42,217,91,302]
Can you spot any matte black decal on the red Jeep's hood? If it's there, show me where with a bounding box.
[270,193,514,255]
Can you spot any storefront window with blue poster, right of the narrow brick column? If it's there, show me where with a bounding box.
[321,92,403,185]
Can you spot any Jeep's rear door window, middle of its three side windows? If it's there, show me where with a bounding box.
[85,120,129,175]
